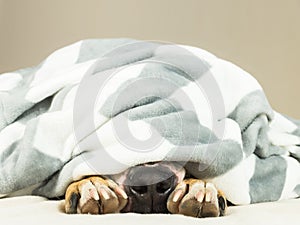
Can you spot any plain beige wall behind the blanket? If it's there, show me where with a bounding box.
[0,0,300,119]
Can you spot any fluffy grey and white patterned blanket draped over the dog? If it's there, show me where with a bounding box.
[0,39,300,204]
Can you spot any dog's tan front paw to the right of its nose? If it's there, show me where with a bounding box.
[167,179,227,217]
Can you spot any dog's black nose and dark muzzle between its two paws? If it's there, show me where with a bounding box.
[123,164,177,213]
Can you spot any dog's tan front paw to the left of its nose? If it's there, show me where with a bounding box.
[65,176,128,214]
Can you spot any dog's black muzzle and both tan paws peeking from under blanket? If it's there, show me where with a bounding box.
[65,162,227,218]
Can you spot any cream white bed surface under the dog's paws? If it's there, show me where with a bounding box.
[0,196,300,225]
